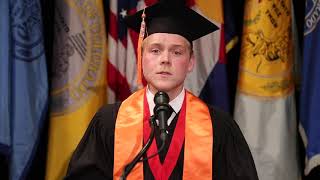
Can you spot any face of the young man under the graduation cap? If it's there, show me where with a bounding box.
[142,33,194,97]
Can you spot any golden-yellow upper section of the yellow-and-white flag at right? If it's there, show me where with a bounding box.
[238,0,293,97]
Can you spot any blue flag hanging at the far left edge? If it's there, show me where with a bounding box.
[0,0,48,180]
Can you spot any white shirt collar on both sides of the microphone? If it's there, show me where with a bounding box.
[146,86,185,116]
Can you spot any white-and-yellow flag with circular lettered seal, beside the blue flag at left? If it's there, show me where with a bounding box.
[46,0,107,180]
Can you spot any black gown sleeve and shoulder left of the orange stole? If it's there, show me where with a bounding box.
[65,103,121,180]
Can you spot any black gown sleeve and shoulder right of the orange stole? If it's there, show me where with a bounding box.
[210,107,258,180]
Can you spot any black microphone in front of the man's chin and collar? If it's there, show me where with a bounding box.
[153,91,171,142]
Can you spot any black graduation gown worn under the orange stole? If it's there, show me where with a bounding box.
[65,103,258,180]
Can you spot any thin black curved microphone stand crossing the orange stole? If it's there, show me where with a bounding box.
[120,116,156,180]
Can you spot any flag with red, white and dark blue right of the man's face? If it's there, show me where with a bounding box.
[185,0,230,111]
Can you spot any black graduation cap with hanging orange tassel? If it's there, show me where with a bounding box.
[125,0,218,84]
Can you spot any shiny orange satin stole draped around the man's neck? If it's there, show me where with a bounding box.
[113,88,213,180]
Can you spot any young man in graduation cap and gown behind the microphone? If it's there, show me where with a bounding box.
[66,1,258,180]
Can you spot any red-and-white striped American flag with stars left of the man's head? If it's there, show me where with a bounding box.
[107,0,139,103]
